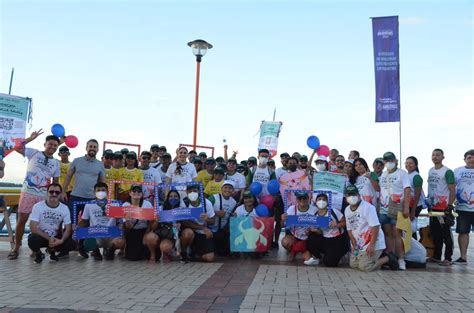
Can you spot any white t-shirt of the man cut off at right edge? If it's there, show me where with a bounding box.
[454,166,474,212]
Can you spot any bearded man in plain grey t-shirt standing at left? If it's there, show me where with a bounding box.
[63,139,105,222]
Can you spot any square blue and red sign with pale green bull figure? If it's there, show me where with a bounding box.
[229,216,275,252]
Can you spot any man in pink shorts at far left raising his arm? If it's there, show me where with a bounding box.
[8,129,60,260]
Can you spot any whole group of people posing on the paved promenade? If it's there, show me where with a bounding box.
[5,130,474,271]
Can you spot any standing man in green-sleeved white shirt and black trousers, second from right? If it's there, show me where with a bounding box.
[428,149,456,265]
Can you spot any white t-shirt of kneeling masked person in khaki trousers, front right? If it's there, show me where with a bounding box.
[344,200,385,251]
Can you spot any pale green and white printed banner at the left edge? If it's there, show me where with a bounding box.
[0,93,31,157]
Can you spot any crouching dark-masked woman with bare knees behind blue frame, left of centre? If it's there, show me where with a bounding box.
[143,190,182,262]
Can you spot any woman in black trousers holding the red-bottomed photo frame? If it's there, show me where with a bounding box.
[122,185,153,261]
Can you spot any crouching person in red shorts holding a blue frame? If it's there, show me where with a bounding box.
[281,192,317,262]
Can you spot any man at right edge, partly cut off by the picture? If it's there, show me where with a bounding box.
[454,149,474,264]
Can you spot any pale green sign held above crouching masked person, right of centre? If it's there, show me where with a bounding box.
[313,172,347,211]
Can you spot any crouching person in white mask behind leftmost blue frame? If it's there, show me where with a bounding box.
[77,182,125,261]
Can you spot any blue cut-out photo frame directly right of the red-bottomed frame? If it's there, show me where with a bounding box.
[155,182,205,222]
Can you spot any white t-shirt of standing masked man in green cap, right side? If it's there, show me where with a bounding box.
[379,168,411,214]
